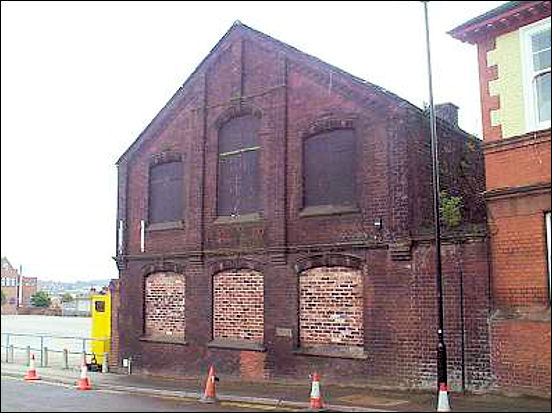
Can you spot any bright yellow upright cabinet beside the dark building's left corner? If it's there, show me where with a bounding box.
[91,292,111,364]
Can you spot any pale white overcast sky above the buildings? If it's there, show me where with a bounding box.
[1,1,505,281]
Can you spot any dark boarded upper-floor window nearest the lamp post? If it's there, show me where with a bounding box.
[303,129,356,207]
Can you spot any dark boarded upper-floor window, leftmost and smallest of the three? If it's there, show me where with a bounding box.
[148,161,184,224]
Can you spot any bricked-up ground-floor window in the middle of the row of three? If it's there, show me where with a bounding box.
[213,270,264,343]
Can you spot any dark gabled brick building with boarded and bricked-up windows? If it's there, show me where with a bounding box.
[111,22,490,388]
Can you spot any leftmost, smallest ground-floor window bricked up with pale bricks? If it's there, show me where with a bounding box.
[144,272,186,340]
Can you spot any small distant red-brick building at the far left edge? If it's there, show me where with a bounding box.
[1,257,37,313]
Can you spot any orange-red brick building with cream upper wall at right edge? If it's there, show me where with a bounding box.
[450,1,551,396]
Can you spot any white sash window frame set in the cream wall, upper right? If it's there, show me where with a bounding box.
[519,17,550,132]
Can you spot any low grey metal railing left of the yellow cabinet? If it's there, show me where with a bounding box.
[1,332,109,372]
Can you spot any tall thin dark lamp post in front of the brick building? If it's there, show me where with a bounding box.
[422,1,447,390]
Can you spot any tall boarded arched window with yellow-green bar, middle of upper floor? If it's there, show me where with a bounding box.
[217,115,261,216]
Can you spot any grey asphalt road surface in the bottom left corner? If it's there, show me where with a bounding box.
[0,376,280,412]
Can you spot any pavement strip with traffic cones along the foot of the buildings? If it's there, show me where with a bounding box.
[1,361,551,412]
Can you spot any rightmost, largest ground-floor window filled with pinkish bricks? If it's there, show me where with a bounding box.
[299,267,364,346]
